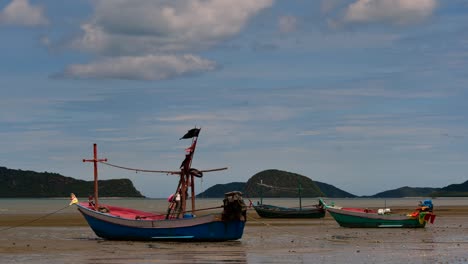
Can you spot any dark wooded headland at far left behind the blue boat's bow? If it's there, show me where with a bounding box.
[0,167,144,198]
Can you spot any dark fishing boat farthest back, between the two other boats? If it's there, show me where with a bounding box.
[251,181,325,218]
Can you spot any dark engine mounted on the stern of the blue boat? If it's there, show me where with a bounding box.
[222,191,247,221]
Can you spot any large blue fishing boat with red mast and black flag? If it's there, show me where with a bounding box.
[71,128,247,241]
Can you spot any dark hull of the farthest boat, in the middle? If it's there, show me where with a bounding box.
[254,204,325,218]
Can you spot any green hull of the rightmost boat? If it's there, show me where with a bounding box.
[327,207,426,228]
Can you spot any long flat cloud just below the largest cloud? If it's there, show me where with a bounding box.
[55,54,216,80]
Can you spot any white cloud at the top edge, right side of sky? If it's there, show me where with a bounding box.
[344,0,437,25]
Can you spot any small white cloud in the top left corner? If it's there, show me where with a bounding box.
[0,0,49,27]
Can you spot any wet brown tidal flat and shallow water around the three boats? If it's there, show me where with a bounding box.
[0,197,468,264]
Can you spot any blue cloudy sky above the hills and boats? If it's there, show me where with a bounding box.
[0,0,468,198]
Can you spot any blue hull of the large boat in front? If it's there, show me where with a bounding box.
[78,205,245,241]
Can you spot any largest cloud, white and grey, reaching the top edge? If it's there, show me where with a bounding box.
[73,0,273,55]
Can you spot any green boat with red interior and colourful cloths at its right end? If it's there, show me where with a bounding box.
[320,199,436,228]
